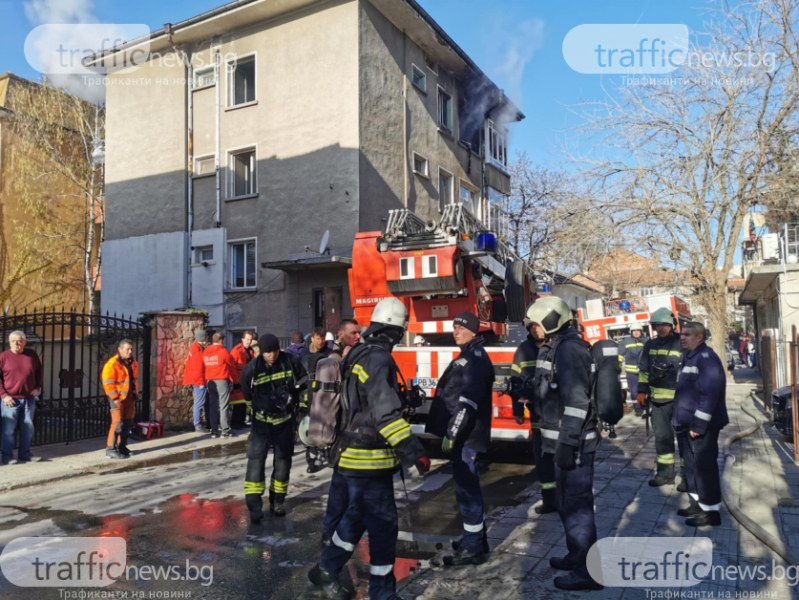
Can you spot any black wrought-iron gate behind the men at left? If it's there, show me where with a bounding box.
[0,309,150,445]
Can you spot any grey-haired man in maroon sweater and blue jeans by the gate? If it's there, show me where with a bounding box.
[0,331,44,464]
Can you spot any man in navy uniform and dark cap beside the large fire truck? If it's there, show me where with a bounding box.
[426,311,494,566]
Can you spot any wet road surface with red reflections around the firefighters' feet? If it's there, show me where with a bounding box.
[0,436,535,600]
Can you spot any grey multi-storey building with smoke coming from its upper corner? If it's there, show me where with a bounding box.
[89,0,523,336]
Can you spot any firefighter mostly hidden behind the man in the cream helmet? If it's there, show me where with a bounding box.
[511,317,558,515]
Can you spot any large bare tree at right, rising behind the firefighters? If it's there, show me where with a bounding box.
[586,0,799,351]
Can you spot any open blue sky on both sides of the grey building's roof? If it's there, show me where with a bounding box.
[0,0,710,166]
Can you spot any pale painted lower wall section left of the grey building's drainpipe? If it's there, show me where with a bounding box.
[101,231,186,316]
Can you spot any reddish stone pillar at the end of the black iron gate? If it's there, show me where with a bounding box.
[148,311,206,429]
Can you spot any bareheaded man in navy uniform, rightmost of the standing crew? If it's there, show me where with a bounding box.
[672,323,730,527]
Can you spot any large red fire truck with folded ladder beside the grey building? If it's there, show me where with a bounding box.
[349,204,535,441]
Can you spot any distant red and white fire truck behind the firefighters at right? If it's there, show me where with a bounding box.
[577,294,691,344]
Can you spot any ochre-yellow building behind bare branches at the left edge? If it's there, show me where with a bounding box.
[0,81,104,312]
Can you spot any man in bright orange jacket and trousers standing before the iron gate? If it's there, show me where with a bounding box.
[102,339,139,459]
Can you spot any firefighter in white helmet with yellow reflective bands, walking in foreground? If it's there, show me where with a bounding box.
[308,298,430,600]
